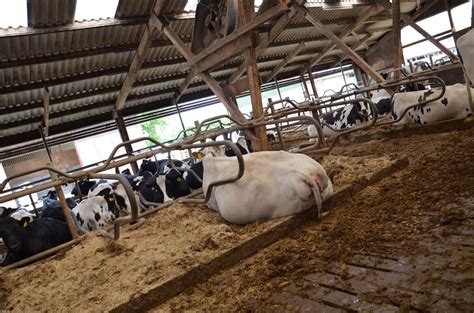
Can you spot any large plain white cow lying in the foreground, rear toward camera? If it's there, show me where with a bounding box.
[202,151,333,224]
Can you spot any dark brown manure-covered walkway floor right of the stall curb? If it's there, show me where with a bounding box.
[154,123,474,312]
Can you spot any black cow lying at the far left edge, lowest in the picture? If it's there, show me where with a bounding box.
[0,216,72,266]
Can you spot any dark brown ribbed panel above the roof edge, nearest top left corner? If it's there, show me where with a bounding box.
[27,0,76,27]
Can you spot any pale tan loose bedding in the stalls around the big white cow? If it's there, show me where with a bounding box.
[0,151,394,312]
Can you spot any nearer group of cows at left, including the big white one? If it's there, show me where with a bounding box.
[0,144,332,266]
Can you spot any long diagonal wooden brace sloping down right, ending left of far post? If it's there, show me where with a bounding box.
[292,5,385,83]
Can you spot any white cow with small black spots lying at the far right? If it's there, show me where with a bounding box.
[392,84,473,125]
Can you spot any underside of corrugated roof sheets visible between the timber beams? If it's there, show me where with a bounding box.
[0,0,456,156]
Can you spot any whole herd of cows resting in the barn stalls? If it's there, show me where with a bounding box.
[0,30,474,266]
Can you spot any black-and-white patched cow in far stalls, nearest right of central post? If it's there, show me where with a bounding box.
[308,102,370,137]
